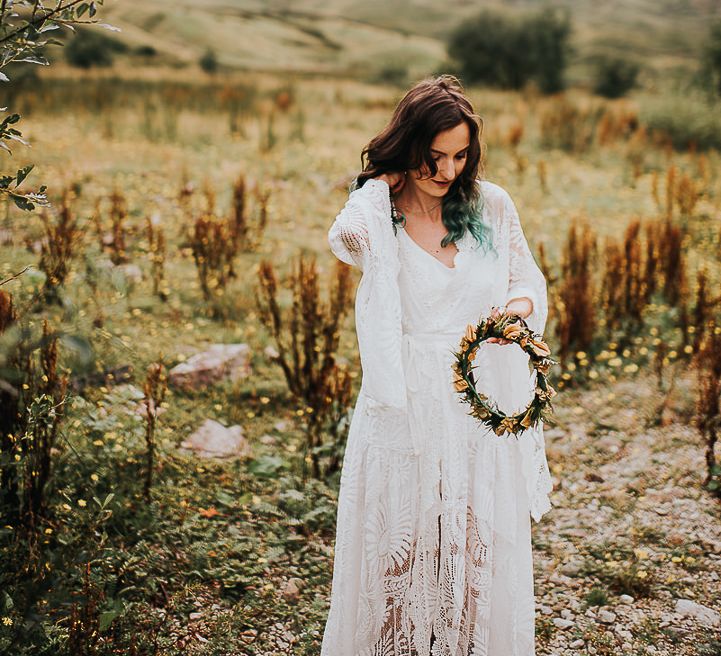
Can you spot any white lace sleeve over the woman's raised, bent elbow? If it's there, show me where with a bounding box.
[328,178,391,271]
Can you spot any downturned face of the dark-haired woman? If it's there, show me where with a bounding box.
[408,121,471,197]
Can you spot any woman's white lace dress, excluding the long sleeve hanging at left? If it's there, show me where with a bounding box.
[321,180,551,656]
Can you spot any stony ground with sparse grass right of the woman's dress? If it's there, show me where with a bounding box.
[533,376,721,656]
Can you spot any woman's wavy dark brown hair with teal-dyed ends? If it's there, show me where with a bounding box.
[349,74,497,255]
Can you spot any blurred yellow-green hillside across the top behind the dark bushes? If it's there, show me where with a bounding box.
[95,0,721,82]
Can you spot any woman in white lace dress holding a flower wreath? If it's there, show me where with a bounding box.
[321,75,552,656]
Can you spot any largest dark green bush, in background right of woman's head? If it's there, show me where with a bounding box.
[448,10,571,93]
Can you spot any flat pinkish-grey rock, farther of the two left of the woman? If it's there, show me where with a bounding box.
[168,344,250,391]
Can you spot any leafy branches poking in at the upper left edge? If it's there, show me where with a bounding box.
[0,0,117,210]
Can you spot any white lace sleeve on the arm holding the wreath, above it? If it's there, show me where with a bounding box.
[504,191,548,335]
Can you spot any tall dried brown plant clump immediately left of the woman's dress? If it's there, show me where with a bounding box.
[256,254,352,477]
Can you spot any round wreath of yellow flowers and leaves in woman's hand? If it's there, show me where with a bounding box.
[453,313,558,438]
